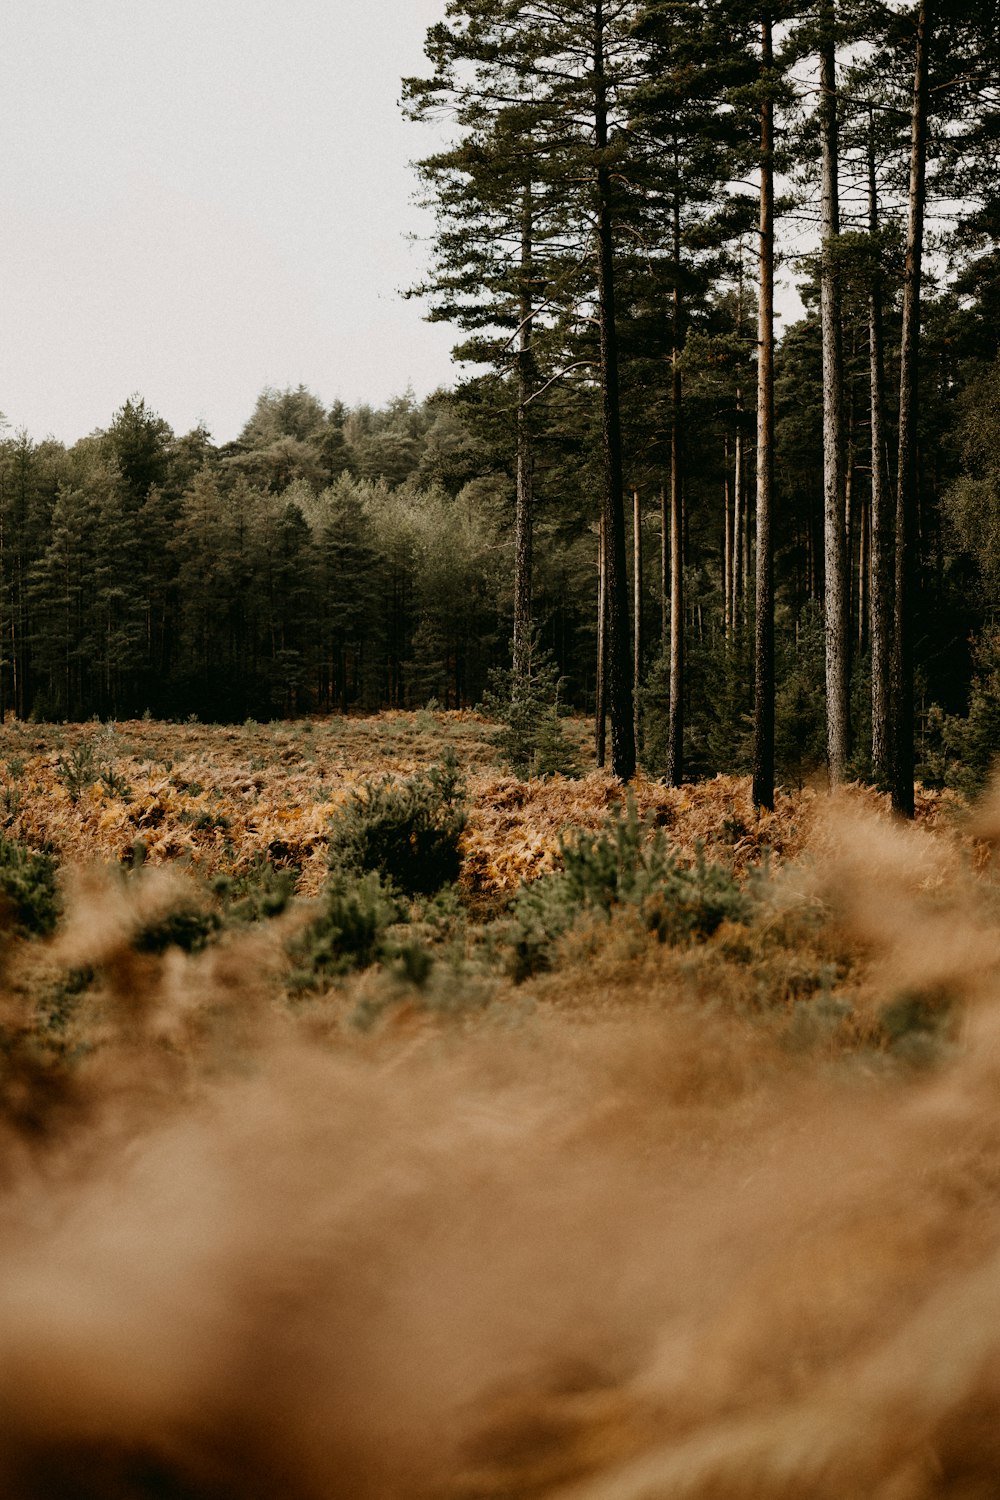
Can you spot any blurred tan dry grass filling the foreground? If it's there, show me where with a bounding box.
[0,804,1000,1500]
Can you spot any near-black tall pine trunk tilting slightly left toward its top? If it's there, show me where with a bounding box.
[594,0,636,782]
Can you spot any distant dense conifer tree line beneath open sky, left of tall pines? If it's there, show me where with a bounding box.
[0,387,539,719]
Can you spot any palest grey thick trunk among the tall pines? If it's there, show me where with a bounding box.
[820,0,849,786]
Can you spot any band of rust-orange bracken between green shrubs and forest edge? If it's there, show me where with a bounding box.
[0,711,958,896]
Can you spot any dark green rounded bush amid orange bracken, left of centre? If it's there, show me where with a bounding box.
[330,750,466,896]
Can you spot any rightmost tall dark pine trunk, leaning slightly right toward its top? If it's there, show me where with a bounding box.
[891,0,931,818]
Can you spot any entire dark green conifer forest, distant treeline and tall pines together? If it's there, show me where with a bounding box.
[0,0,1000,812]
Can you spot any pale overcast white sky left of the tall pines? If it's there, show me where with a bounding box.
[0,0,457,443]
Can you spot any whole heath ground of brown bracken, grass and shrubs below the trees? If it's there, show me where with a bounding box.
[0,713,1000,1500]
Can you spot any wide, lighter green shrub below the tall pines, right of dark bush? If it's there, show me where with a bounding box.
[508,798,750,980]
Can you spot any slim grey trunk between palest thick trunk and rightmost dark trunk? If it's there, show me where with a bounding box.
[868,111,894,783]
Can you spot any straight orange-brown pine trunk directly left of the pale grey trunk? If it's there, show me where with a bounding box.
[753,11,774,809]
